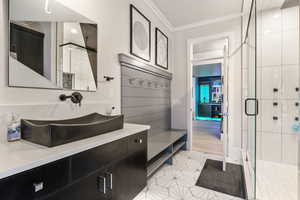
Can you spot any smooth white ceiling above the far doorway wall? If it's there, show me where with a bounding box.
[152,0,242,28]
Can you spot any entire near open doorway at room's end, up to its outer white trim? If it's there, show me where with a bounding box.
[187,35,229,161]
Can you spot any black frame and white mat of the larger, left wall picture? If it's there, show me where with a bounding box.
[130,4,151,62]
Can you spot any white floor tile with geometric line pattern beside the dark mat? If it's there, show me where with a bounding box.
[134,151,244,200]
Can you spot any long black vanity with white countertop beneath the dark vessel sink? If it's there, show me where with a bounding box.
[0,124,150,200]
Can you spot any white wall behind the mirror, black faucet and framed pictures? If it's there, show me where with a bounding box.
[0,0,172,140]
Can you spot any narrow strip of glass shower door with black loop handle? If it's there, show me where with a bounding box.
[243,0,258,199]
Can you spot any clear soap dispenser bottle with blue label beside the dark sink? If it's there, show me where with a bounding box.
[7,113,21,142]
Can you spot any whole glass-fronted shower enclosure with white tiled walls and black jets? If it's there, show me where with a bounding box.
[242,0,300,200]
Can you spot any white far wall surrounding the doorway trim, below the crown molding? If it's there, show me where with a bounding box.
[172,18,241,159]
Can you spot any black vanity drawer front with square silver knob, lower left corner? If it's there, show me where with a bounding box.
[0,159,69,200]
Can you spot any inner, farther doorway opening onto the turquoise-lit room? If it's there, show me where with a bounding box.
[192,63,223,155]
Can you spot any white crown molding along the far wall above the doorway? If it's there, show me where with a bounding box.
[173,13,243,32]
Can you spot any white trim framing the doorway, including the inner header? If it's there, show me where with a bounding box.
[186,32,234,161]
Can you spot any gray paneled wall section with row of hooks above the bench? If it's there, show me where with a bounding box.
[120,54,171,135]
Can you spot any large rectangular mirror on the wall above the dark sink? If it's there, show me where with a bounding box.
[9,0,98,91]
